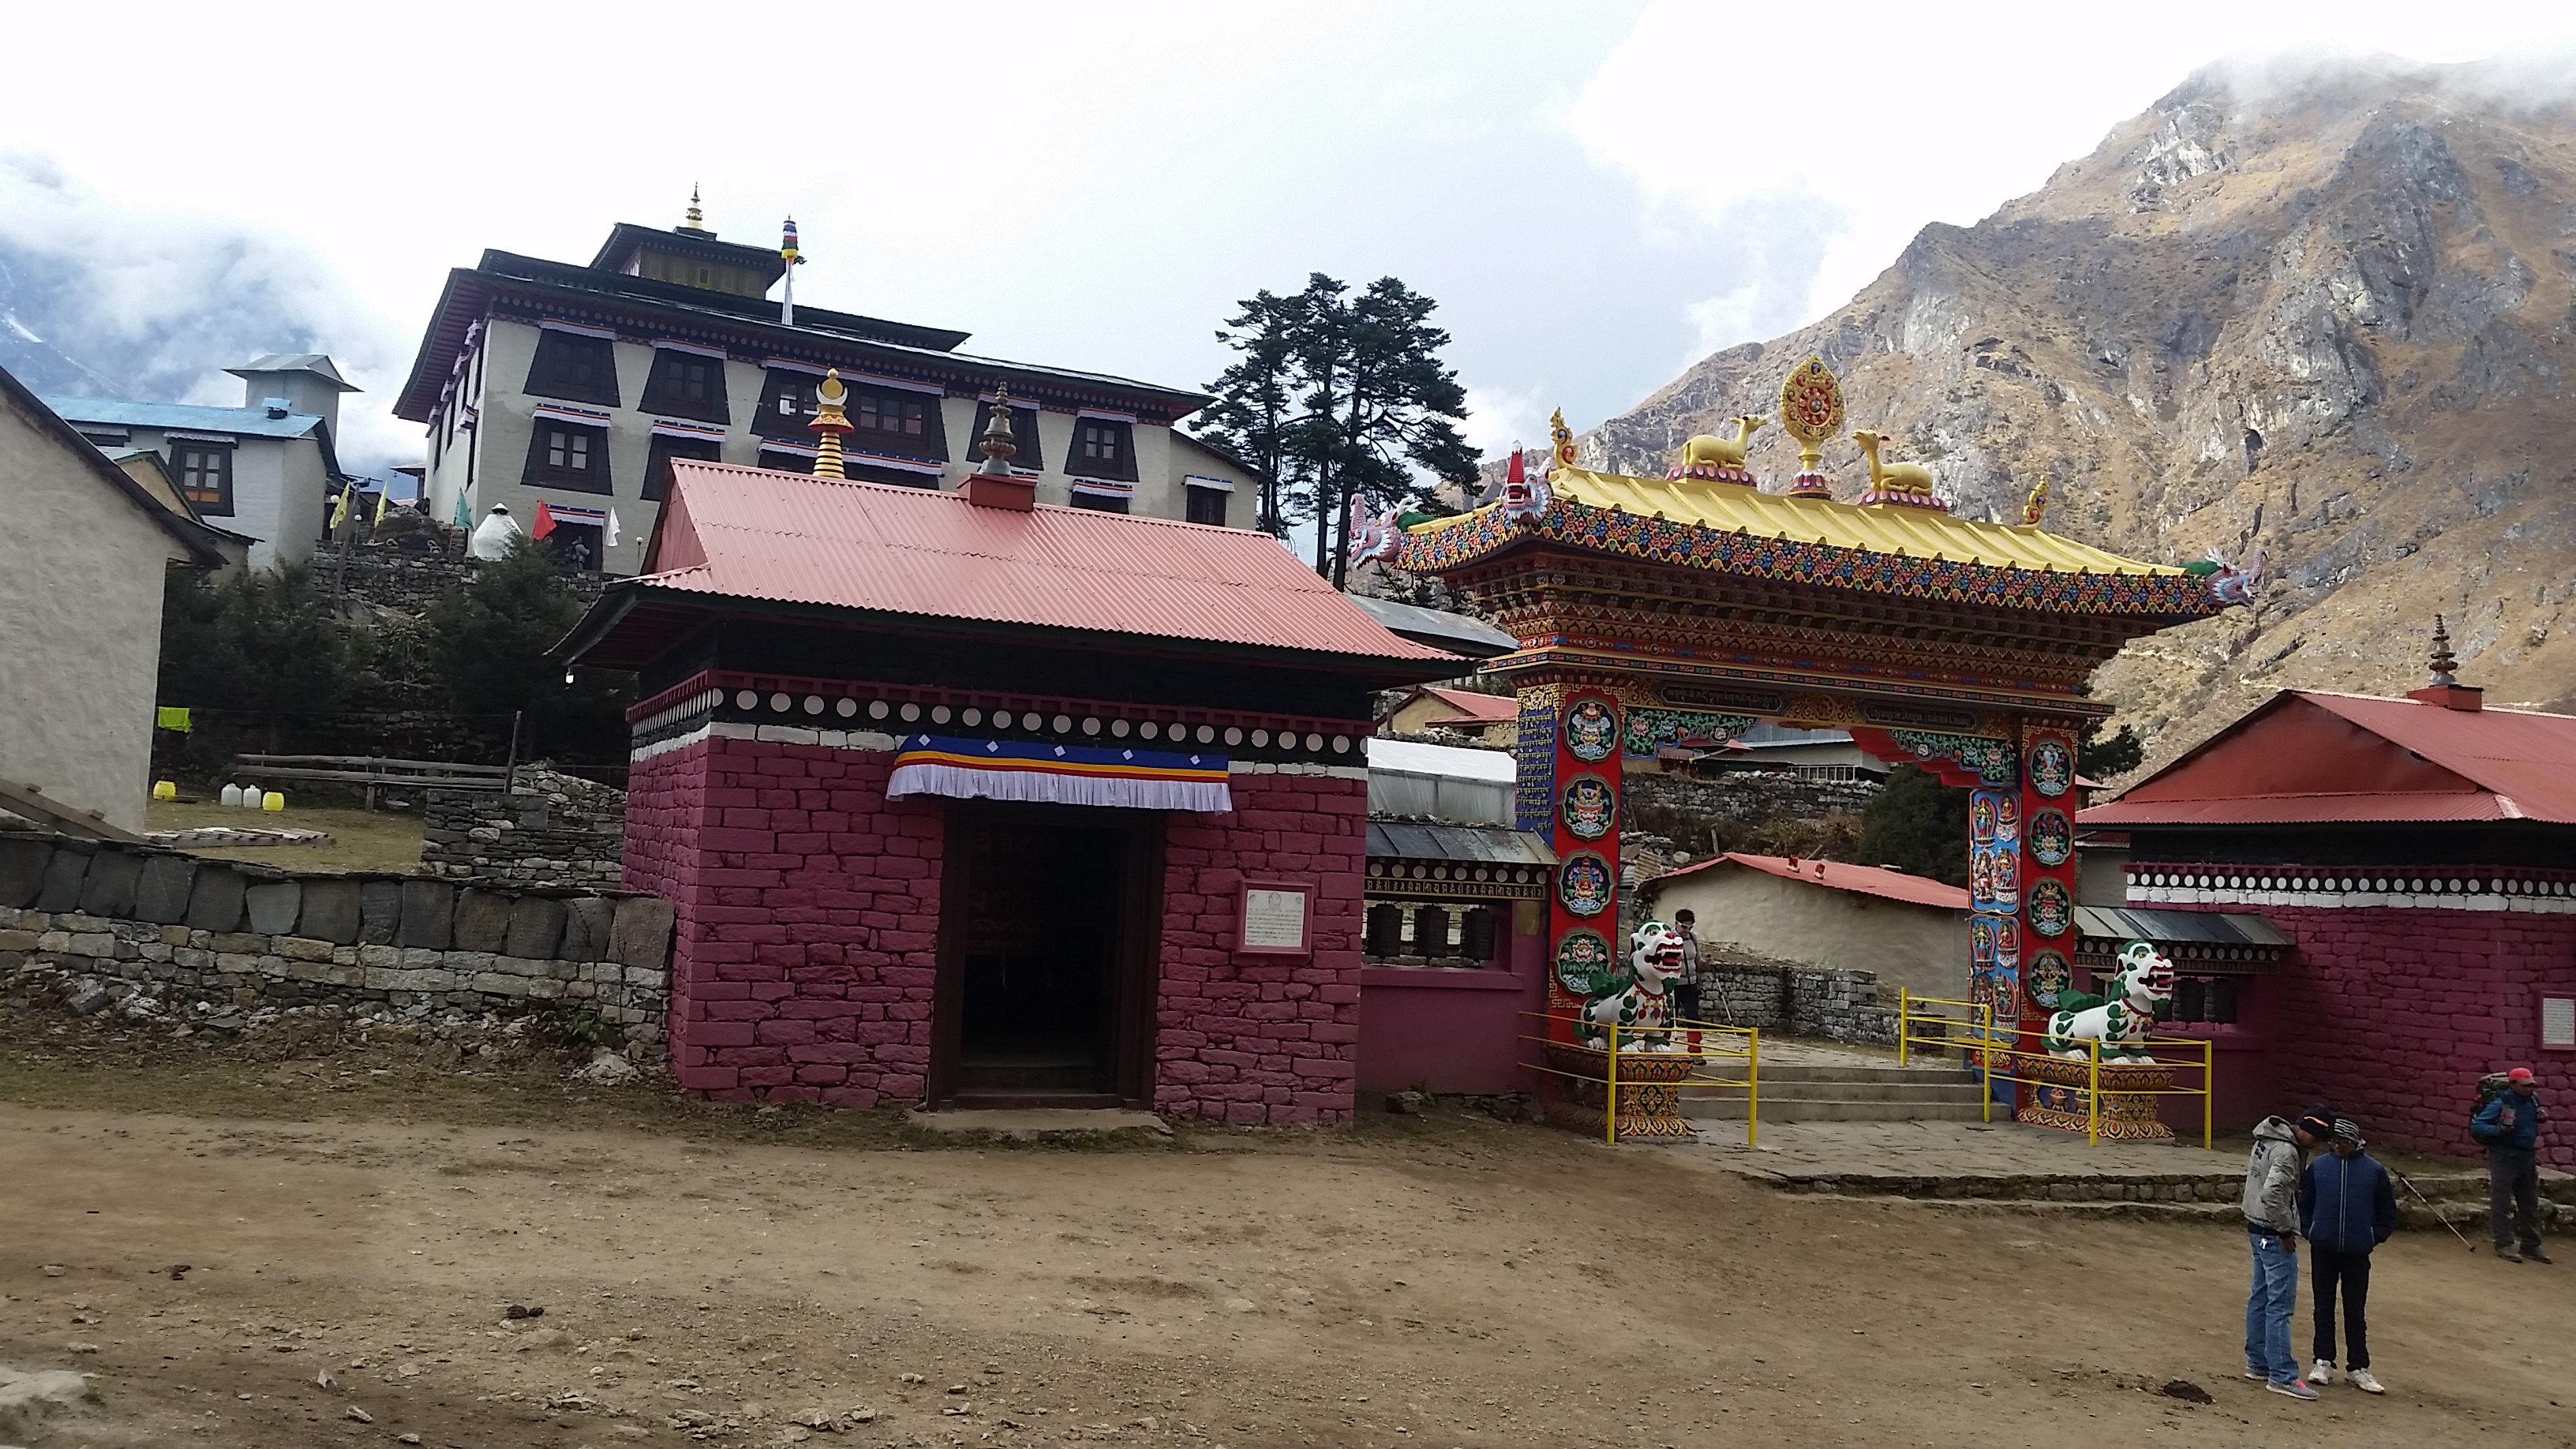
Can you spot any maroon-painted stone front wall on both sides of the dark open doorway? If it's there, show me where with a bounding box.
[626,737,1368,1121]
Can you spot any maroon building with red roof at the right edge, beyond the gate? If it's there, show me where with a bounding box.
[2079,657,2576,1168]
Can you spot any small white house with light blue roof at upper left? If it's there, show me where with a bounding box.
[43,354,355,570]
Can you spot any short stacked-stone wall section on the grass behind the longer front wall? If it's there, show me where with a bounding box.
[420,766,626,889]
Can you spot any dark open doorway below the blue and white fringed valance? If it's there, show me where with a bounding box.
[927,799,1164,1109]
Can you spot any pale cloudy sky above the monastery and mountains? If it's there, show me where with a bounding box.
[0,0,2576,466]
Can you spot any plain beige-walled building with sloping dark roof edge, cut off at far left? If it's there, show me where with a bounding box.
[0,361,224,830]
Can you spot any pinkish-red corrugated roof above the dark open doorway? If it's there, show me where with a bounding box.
[636,462,1451,660]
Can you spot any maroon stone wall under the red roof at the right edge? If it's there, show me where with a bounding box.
[2169,905,2576,1168]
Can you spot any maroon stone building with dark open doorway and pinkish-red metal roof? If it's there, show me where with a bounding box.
[567,462,1463,1121]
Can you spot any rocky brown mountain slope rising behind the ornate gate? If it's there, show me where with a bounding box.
[1582,67,2576,763]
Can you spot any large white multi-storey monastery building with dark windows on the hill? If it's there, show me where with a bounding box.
[394,208,1257,575]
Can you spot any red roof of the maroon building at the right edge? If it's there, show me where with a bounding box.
[2076,688,2576,828]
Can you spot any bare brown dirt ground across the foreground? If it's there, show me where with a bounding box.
[0,1018,2576,1449]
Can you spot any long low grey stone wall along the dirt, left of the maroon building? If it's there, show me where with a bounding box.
[0,835,672,1062]
